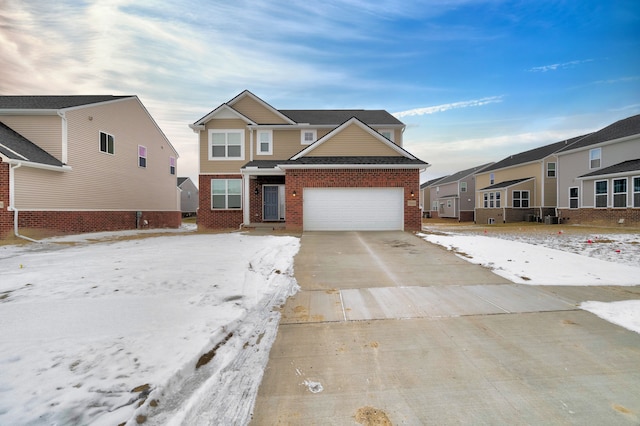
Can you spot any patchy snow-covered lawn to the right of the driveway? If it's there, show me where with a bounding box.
[420,225,640,333]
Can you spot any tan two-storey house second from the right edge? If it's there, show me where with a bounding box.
[475,136,583,223]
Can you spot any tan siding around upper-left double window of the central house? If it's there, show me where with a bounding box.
[200,118,250,174]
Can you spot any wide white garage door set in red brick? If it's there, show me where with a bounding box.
[303,188,404,231]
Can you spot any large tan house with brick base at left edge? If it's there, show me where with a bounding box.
[0,96,180,237]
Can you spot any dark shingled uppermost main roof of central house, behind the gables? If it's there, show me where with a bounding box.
[280,109,404,126]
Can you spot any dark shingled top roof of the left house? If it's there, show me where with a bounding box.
[0,95,133,110]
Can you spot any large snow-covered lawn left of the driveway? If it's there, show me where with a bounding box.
[0,232,299,425]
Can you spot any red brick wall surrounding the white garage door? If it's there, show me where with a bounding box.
[285,169,421,231]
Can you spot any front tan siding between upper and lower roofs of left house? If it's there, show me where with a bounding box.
[0,115,62,161]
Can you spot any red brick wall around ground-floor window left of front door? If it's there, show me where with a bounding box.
[197,175,242,229]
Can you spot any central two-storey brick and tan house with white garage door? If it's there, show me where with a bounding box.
[190,90,428,230]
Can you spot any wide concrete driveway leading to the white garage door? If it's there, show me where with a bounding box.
[252,232,640,425]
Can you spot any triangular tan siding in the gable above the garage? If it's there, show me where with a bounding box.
[306,125,401,157]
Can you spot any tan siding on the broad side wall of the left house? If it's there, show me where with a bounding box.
[15,98,179,211]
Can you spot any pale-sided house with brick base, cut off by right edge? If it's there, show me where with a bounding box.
[557,115,640,226]
